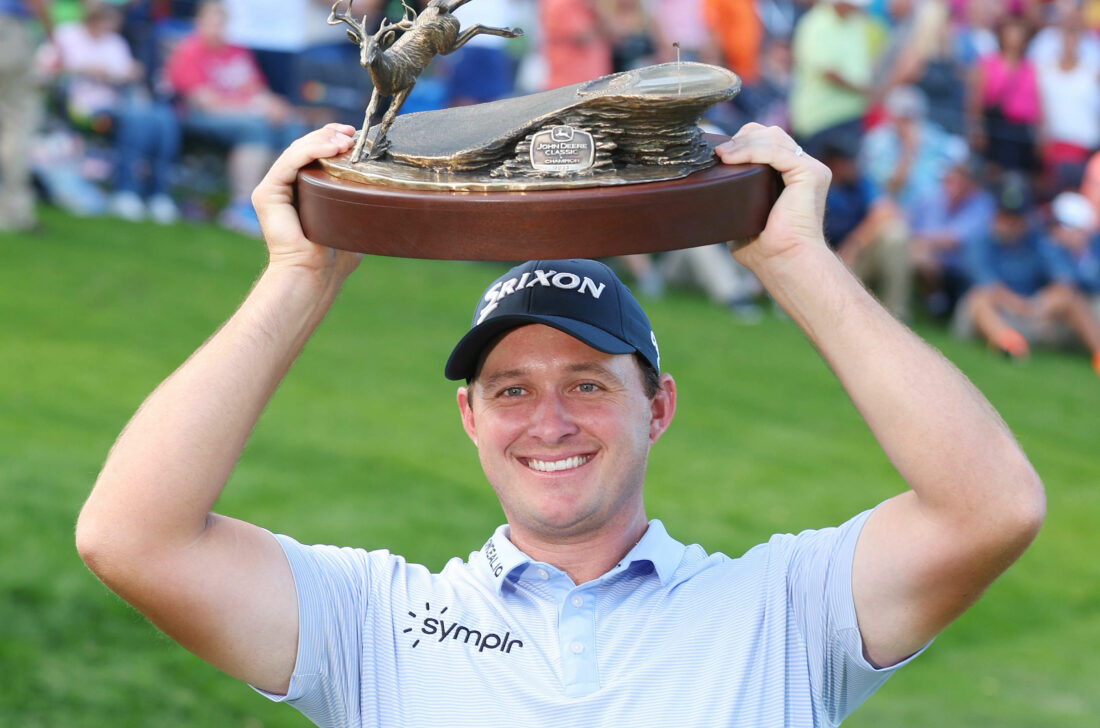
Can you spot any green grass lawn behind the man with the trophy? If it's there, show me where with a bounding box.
[0,211,1100,728]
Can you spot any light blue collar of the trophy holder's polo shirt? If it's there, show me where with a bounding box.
[479,518,684,594]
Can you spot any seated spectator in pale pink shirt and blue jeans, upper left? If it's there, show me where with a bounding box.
[54,0,179,224]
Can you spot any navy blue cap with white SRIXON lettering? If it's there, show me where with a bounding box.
[443,260,661,380]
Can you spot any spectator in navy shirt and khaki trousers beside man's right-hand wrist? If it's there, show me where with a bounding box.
[821,133,911,317]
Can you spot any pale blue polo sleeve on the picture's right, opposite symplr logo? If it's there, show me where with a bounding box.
[788,510,923,726]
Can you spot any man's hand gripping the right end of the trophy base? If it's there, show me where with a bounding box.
[714,123,832,273]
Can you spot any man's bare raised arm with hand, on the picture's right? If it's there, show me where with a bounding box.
[717,124,1045,666]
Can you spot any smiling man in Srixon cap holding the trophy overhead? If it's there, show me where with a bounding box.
[77,124,1045,727]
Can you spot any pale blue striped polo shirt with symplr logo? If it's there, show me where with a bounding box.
[255,511,919,728]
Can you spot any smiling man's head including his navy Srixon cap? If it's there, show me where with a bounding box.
[446,261,675,540]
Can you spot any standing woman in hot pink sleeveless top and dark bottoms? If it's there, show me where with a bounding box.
[968,16,1041,172]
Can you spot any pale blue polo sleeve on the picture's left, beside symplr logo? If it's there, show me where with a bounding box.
[253,536,396,727]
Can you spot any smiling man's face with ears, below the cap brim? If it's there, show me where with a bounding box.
[458,324,675,540]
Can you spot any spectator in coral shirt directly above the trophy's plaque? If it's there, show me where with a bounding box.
[539,0,612,88]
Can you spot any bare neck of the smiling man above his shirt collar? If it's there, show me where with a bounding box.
[509,508,649,584]
